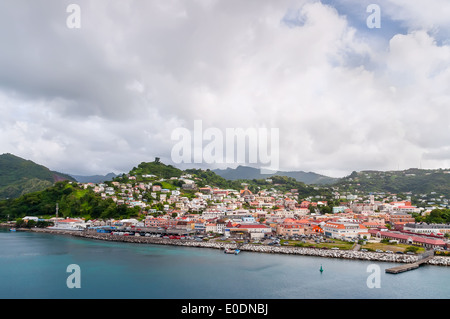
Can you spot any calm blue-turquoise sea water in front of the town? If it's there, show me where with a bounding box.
[0,230,450,299]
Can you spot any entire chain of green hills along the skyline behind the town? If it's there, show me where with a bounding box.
[0,153,450,200]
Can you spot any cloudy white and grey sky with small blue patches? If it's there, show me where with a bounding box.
[0,0,450,177]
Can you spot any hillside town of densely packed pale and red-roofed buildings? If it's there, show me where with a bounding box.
[16,174,450,253]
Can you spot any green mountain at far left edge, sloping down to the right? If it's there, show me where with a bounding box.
[0,153,75,199]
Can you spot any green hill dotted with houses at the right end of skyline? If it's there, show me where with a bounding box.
[334,168,450,198]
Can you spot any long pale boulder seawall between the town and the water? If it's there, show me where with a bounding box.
[20,228,450,266]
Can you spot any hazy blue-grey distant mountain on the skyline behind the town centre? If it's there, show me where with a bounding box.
[213,165,339,185]
